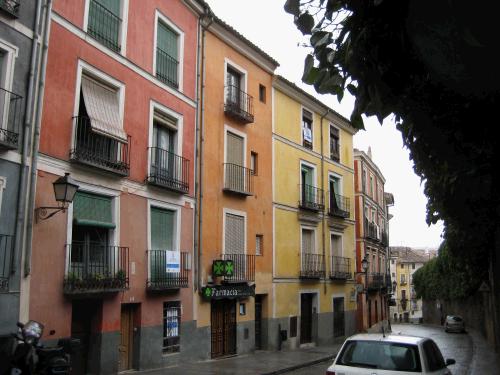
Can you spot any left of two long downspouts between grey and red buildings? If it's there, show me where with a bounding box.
[11,0,42,274]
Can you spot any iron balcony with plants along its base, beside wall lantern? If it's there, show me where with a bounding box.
[64,242,129,295]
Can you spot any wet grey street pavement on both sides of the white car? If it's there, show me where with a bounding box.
[140,324,500,375]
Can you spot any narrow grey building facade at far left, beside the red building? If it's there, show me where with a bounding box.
[0,0,47,348]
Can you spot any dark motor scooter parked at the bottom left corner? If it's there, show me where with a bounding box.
[5,320,80,375]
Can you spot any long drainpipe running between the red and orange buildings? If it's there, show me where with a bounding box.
[195,6,213,290]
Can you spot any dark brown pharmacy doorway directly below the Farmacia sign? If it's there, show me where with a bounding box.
[211,299,236,358]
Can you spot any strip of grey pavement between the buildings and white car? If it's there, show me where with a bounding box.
[139,344,341,375]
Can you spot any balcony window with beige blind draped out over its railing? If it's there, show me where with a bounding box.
[70,75,130,176]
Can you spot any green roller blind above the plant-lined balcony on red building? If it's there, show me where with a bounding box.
[73,192,116,228]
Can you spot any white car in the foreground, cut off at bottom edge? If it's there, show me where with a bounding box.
[326,333,455,375]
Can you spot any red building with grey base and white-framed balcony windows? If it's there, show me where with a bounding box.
[29,0,203,374]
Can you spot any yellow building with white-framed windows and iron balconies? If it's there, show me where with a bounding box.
[269,76,357,348]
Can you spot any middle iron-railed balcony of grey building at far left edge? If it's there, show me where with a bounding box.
[0,87,23,150]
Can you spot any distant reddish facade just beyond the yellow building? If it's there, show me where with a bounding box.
[354,149,394,331]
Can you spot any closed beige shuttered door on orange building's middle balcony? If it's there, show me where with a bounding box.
[225,132,247,191]
